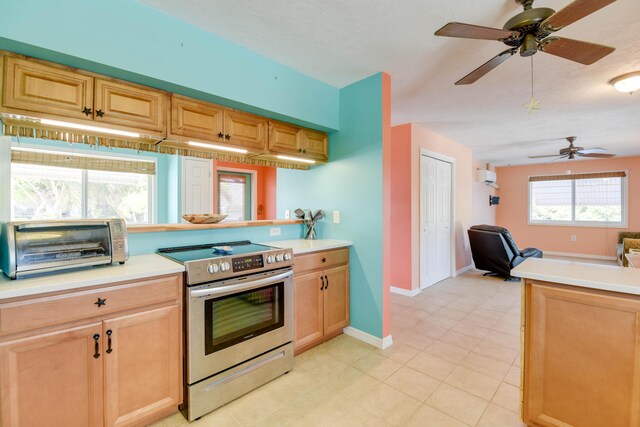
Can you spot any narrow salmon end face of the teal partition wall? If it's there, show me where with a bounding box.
[382,73,393,338]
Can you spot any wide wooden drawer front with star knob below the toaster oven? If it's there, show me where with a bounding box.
[0,275,181,335]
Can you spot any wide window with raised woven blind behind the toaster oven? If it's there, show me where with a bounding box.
[11,148,156,224]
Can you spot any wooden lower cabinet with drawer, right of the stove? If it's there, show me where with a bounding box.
[293,249,349,353]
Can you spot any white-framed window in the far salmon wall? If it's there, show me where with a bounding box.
[529,171,627,227]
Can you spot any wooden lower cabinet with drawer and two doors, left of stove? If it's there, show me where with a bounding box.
[0,275,182,427]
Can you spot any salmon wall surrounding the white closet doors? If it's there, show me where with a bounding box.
[390,124,495,290]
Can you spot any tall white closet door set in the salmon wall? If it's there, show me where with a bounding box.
[420,155,453,288]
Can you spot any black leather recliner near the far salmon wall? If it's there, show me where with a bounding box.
[468,225,542,280]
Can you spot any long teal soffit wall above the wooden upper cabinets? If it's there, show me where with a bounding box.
[0,0,339,130]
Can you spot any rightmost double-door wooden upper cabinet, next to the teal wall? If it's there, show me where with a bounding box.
[269,120,328,162]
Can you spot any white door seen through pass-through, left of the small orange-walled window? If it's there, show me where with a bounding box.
[182,157,213,219]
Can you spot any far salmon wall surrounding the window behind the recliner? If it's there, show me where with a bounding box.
[496,157,640,257]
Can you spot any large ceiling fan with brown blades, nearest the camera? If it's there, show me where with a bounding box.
[435,0,616,85]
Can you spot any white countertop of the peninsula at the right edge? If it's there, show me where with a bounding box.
[511,258,640,295]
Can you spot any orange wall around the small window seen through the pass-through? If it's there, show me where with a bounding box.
[213,160,276,219]
